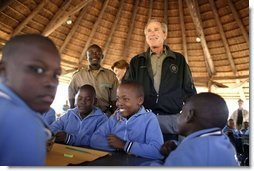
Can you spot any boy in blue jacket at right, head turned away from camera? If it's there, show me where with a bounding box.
[152,93,239,166]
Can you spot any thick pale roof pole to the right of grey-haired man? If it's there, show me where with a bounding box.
[185,0,216,77]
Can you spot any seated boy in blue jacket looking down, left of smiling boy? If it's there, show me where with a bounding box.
[50,84,108,146]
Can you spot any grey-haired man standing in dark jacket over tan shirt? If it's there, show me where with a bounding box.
[123,19,197,140]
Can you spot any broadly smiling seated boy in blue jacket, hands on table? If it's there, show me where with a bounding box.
[90,82,163,159]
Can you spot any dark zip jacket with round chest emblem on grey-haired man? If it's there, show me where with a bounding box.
[123,46,197,115]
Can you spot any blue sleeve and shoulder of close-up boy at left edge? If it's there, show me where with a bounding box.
[0,106,46,166]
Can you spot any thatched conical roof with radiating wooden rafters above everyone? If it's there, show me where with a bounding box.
[0,0,250,100]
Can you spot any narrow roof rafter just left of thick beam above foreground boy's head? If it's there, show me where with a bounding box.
[42,0,71,36]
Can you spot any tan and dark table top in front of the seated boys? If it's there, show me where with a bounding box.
[46,143,157,166]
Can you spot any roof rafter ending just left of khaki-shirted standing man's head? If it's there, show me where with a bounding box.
[78,0,109,66]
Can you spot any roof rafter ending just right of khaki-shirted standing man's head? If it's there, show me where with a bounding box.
[102,0,124,57]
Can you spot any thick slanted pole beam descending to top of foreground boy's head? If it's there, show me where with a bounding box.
[43,0,95,36]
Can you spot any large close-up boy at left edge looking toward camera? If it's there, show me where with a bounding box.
[0,34,61,166]
